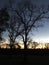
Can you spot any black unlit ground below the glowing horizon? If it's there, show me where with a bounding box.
[0,49,49,65]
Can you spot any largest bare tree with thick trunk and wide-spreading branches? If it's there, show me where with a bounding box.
[15,0,48,49]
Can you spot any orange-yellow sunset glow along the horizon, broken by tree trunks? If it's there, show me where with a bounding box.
[0,43,49,49]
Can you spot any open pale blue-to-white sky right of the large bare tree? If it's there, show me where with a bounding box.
[33,19,49,43]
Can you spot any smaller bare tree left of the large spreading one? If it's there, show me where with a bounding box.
[7,14,23,48]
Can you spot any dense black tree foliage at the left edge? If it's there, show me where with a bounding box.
[0,8,9,41]
